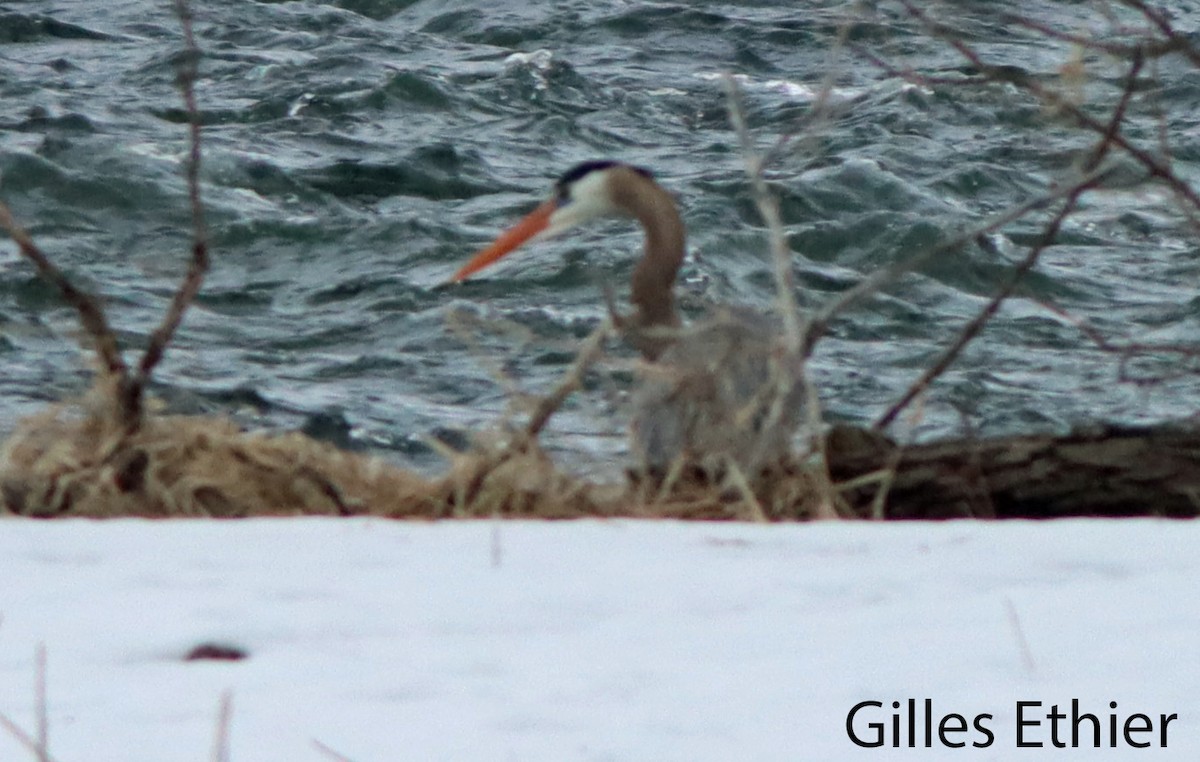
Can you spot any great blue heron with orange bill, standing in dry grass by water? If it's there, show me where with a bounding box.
[454,161,800,473]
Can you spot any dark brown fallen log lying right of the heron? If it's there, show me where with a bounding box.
[827,424,1200,518]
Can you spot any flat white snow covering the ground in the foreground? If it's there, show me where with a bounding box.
[0,518,1200,762]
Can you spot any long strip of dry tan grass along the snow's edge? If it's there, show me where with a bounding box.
[0,376,835,520]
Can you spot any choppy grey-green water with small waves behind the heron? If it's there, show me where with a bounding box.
[0,0,1200,477]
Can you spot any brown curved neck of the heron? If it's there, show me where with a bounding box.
[611,169,686,359]
